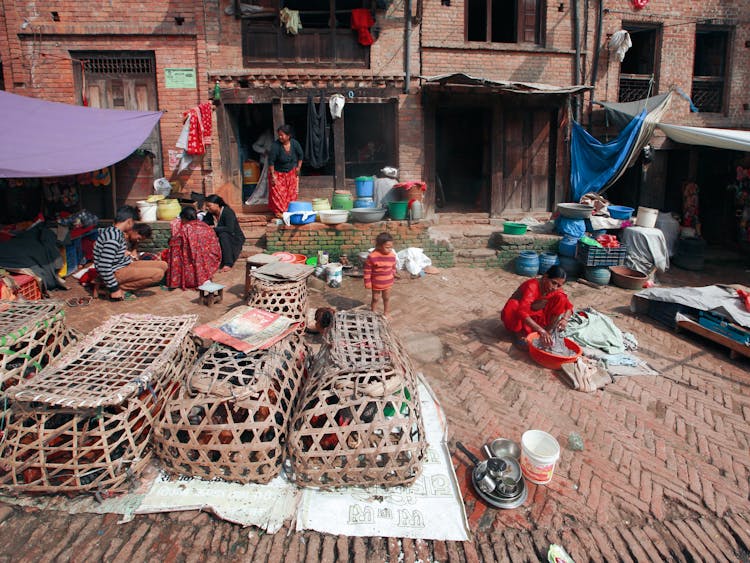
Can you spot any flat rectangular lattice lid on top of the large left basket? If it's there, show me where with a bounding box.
[8,314,197,408]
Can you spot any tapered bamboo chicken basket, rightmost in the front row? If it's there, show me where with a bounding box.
[285,311,427,488]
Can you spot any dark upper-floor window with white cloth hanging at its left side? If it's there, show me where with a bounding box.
[618,26,658,102]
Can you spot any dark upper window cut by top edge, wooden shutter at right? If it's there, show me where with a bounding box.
[466,0,544,44]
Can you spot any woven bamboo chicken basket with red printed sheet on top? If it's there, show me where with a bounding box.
[154,333,306,483]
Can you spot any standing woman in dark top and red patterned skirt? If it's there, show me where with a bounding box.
[268,125,304,217]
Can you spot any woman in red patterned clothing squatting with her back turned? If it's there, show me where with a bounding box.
[167,207,221,289]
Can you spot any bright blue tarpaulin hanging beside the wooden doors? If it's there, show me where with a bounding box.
[570,110,647,201]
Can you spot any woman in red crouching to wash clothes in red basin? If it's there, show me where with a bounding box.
[500,266,573,347]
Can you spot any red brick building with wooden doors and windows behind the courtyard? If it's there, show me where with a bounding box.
[0,0,750,236]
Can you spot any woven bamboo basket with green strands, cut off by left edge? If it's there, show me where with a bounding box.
[0,300,79,392]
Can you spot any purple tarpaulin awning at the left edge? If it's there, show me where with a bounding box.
[0,91,162,178]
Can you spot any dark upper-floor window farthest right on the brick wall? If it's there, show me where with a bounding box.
[691,28,729,113]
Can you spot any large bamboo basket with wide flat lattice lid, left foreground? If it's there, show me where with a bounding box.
[0,315,197,493]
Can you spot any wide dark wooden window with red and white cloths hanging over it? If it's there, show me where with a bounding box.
[242,0,370,68]
